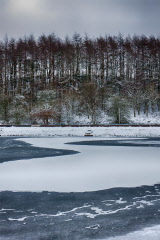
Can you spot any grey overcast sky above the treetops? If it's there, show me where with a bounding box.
[0,0,160,40]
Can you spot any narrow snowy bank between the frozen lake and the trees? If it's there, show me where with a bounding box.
[0,126,160,137]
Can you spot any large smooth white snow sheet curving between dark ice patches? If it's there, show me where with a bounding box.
[0,137,160,192]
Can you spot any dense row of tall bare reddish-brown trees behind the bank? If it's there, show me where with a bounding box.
[0,33,160,123]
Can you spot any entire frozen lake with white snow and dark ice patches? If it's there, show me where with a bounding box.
[0,137,160,240]
